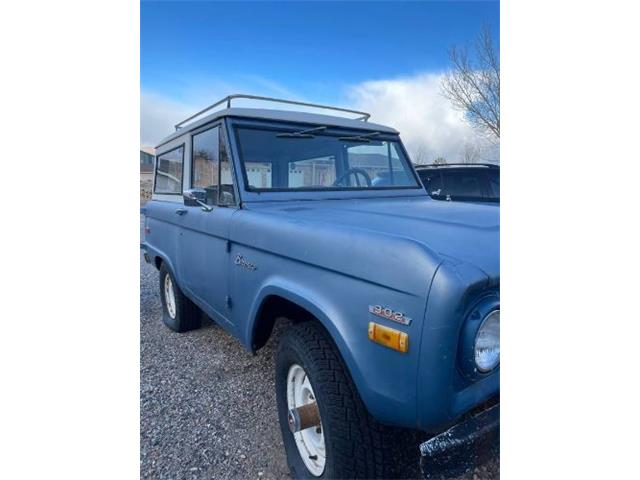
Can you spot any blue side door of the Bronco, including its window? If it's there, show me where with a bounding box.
[178,124,237,324]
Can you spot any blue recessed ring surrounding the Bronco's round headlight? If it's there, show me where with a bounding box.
[458,295,500,381]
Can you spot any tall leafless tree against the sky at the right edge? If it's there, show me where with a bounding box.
[442,25,500,139]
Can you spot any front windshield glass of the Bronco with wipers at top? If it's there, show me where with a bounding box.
[236,126,419,191]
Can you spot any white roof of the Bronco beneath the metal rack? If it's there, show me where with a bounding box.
[156,108,398,148]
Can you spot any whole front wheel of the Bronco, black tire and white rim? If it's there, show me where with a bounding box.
[276,322,419,479]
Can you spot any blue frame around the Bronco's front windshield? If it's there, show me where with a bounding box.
[229,117,426,201]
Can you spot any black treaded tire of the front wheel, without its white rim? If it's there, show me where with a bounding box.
[276,321,420,479]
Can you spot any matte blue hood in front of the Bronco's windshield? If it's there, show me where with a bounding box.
[251,197,500,279]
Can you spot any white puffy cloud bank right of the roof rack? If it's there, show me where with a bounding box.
[347,73,497,163]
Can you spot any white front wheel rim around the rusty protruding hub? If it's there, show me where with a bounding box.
[287,364,327,477]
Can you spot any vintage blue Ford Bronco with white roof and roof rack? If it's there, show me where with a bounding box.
[142,95,500,478]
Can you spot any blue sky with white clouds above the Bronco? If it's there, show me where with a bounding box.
[140,1,500,163]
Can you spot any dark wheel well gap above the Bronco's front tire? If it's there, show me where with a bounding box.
[252,295,318,351]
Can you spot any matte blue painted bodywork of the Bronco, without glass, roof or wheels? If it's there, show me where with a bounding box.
[143,112,500,431]
